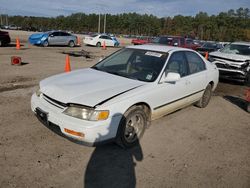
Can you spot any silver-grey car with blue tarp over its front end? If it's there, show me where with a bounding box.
[29,31,77,47]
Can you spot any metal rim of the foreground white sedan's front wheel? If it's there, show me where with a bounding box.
[124,114,144,143]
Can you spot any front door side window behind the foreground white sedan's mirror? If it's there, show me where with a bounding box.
[166,52,188,77]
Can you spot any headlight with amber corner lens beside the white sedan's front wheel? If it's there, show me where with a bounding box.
[63,106,109,121]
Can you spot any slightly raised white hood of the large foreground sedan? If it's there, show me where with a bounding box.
[40,68,144,107]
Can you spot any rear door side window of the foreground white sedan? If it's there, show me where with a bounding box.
[185,52,206,74]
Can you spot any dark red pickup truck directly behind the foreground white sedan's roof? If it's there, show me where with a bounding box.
[153,36,200,50]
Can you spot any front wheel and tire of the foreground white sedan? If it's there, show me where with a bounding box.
[116,106,148,148]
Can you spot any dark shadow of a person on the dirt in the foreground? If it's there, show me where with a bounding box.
[84,144,143,188]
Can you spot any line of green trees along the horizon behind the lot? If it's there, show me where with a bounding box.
[3,8,250,41]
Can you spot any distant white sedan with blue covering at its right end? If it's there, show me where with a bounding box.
[83,34,120,47]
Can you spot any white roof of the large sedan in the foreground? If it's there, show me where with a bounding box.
[126,44,193,52]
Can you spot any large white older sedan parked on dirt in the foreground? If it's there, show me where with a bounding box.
[31,45,219,147]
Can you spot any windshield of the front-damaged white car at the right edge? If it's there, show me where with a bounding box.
[221,44,250,56]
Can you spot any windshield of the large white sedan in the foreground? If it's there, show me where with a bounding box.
[92,48,167,82]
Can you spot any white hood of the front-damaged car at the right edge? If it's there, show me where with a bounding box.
[209,51,250,62]
